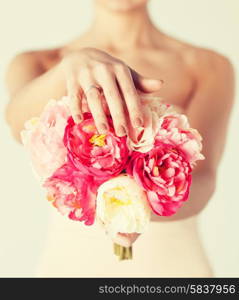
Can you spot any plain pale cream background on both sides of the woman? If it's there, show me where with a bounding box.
[0,0,239,277]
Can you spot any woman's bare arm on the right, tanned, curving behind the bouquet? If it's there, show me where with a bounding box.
[153,52,234,221]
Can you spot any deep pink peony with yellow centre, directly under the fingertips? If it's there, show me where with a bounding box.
[64,113,129,183]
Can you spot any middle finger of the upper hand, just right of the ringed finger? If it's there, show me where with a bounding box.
[99,72,128,136]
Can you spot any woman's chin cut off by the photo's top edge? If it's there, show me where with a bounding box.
[96,0,148,13]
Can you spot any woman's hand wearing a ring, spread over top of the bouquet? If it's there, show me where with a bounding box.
[61,48,162,136]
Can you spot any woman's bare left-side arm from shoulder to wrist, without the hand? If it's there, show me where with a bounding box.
[6,53,65,142]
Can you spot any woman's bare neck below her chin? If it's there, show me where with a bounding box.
[88,6,156,51]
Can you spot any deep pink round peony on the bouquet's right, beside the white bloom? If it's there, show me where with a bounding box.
[127,142,191,216]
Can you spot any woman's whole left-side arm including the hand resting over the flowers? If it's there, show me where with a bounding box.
[6,48,162,141]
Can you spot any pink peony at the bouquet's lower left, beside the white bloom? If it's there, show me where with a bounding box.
[43,164,96,225]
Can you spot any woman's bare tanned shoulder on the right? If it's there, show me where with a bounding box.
[162,35,235,106]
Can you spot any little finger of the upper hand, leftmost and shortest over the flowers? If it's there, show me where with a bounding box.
[66,76,82,123]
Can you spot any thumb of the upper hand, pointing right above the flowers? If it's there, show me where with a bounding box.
[130,69,164,93]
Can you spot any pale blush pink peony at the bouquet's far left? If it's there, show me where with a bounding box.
[21,98,70,179]
